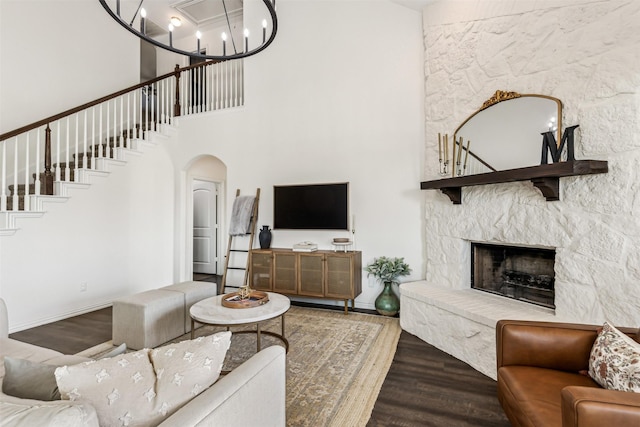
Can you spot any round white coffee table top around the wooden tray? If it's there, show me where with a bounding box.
[189,292,291,326]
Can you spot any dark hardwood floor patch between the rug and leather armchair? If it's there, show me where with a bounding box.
[367,331,511,427]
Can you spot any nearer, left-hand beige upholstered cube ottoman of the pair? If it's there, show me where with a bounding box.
[112,289,185,350]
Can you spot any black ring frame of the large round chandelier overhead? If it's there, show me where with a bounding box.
[98,0,278,61]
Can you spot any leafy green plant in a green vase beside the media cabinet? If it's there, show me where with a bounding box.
[365,256,411,316]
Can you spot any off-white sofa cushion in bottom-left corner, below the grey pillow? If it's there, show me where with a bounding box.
[0,400,99,427]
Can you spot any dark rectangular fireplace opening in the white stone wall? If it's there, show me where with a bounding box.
[471,243,556,309]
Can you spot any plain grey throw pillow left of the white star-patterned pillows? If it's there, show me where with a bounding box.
[2,356,60,401]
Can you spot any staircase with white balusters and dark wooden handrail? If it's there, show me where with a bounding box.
[0,60,244,236]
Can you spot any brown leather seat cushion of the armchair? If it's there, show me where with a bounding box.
[498,365,598,426]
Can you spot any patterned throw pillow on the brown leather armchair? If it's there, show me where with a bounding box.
[589,322,640,393]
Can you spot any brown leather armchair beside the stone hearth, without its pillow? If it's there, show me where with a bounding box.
[496,320,640,427]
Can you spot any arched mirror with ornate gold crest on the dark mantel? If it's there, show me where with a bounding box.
[452,90,562,176]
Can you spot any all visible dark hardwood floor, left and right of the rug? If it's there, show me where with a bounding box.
[11,279,510,427]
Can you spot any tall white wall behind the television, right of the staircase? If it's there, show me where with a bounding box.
[171,1,424,308]
